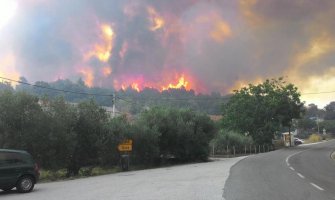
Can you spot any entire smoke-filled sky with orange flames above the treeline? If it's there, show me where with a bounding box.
[0,0,335,108]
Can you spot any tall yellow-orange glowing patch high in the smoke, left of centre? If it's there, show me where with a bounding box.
[85,24,115,62]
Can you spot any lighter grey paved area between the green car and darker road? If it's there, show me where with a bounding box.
[0,158,243,200]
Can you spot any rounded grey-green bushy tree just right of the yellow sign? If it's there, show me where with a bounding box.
[139,107,215,162]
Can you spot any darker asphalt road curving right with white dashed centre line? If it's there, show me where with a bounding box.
[224,140,335,200]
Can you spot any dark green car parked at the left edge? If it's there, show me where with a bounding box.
[0,149,39,193]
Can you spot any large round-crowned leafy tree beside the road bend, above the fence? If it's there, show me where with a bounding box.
[223,78,303,144]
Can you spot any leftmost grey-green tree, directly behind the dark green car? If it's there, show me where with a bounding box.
[0,90,49,164]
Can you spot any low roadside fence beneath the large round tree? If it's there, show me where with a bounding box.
[211,144,274,158]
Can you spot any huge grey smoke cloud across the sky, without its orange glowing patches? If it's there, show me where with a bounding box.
[1,0,335,92]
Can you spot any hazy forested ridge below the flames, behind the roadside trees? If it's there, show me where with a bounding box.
[1,77,229,115]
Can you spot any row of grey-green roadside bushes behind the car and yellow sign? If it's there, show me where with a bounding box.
[0,90,215,179]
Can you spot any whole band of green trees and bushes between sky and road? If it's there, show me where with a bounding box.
[0,78,335,179]
